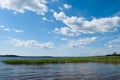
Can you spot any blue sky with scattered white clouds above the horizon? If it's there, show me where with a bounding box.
[0,0,120,56]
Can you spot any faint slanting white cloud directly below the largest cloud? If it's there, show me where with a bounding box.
[69,37,98,47]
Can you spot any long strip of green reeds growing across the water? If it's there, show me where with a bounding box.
[3,56,120,65]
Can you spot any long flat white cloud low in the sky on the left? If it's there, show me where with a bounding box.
[10,39,54,49]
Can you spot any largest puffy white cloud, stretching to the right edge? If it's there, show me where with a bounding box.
[53,12,120,36]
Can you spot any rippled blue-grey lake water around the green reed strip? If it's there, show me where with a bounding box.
[0,57,120,80]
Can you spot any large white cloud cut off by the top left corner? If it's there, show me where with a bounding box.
[0,0,48,15]
